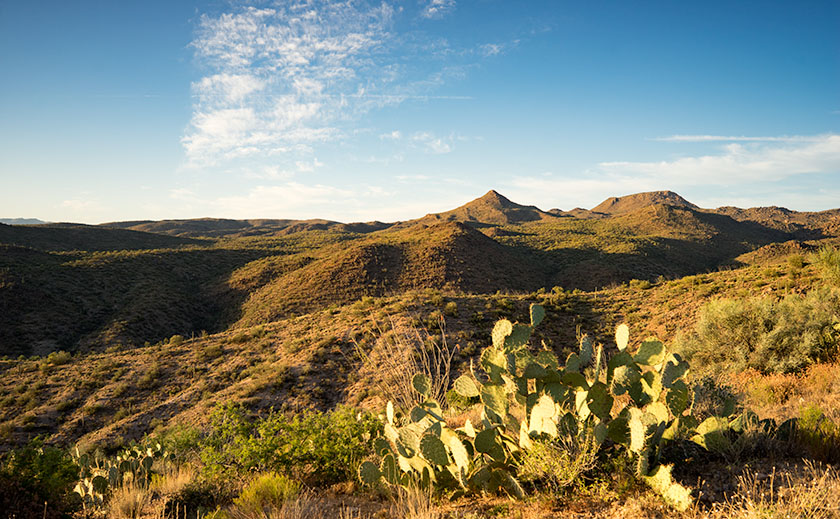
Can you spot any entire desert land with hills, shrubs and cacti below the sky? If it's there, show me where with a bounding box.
[0,194,840,518]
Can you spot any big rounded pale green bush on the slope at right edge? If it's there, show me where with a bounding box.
[677,288,840,373]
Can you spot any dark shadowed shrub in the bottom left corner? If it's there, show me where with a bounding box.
[0,440,81,519]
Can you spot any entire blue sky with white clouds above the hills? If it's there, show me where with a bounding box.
[0,0,840,223]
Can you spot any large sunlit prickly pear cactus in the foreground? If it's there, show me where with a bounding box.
[359,305,730,510]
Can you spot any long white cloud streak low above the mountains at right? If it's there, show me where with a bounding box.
[507,134,840,210]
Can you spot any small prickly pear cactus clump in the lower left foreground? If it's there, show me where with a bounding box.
[73,443,175,507]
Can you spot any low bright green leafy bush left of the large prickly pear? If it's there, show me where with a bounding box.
[199,403,381,483]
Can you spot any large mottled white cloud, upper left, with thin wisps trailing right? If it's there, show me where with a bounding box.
[181,0,486,174]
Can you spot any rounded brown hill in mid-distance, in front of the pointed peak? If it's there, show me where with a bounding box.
[233,222,543,324]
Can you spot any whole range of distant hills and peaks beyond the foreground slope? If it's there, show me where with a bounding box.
[0,191,840,355]
